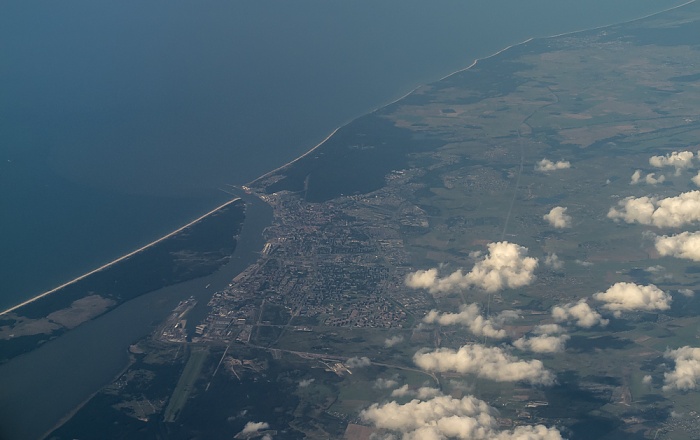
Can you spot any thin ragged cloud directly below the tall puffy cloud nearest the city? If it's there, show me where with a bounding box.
[423,304,518,339]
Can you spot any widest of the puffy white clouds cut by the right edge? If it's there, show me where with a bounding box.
[608,190,700,228]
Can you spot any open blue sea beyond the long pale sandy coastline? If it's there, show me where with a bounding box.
[0,0,682,309]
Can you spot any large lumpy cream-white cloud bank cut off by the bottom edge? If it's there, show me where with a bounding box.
[360,395,562,440]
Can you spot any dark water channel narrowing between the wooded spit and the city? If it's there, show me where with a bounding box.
[0,195,272,439]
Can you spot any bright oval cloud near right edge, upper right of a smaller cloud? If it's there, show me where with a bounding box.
[593,282,672,316]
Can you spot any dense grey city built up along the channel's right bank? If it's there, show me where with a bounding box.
[197,170,440,342]
